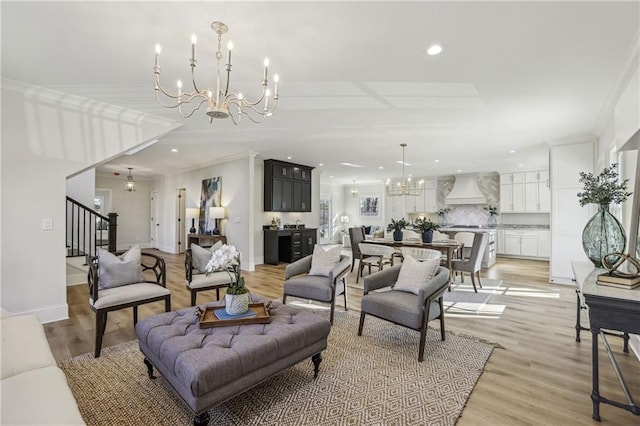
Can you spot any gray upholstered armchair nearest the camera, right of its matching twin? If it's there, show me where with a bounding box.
[358,265,449,362]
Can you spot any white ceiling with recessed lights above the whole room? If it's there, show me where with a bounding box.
[2,1,640,183]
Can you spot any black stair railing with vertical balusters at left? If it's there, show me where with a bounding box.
[67,197,118,257]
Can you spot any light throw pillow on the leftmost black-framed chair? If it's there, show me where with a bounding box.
[98,245,144,290]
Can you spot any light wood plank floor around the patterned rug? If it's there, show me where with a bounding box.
[45,253,640,426]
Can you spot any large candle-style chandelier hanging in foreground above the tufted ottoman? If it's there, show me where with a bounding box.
[153,22,278,125]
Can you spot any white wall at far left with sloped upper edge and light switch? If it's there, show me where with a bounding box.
[0,80,180,322]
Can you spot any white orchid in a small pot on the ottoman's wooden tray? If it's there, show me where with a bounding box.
[205,244,251,315]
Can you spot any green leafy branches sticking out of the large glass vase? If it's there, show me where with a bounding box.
[578,163,632,206]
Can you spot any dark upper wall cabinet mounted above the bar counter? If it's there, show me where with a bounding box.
[264,160,313,212]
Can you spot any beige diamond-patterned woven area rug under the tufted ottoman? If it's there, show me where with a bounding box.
[60,310,493,426]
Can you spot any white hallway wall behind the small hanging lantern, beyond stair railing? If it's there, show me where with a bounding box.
[95,174,151,250]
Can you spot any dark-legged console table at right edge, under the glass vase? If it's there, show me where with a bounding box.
[571,262,640,421]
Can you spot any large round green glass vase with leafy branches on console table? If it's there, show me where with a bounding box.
[577,163,632,267]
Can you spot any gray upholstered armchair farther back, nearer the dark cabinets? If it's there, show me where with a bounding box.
[282,255,349,324]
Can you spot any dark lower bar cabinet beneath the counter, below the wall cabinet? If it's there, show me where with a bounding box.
[264,229,318,265]
